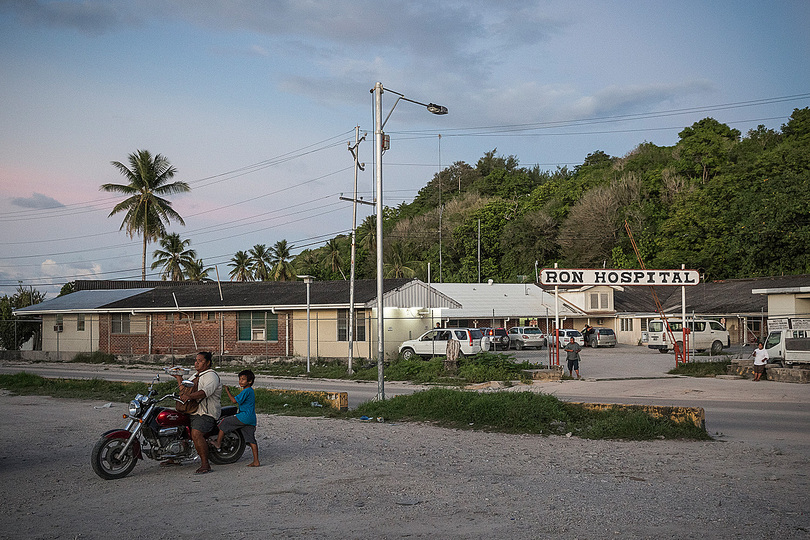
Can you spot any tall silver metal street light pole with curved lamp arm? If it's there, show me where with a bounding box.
[371,82,447,401]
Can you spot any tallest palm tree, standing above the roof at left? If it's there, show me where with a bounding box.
[101,150,191,281]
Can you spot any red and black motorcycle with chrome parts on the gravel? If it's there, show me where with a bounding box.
[91,375,245,480]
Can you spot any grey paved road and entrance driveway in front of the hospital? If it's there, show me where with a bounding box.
[0,345,810,456]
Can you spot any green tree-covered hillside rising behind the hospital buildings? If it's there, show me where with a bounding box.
[293,108,810,282]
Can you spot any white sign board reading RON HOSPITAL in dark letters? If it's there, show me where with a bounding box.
[540,268,700,286]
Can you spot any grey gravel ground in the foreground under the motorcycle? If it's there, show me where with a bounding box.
[0,392,810,539]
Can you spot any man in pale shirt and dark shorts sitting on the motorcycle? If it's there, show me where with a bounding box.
[163,351,222,474]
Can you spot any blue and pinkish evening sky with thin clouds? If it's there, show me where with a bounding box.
[0,0,810,298]
